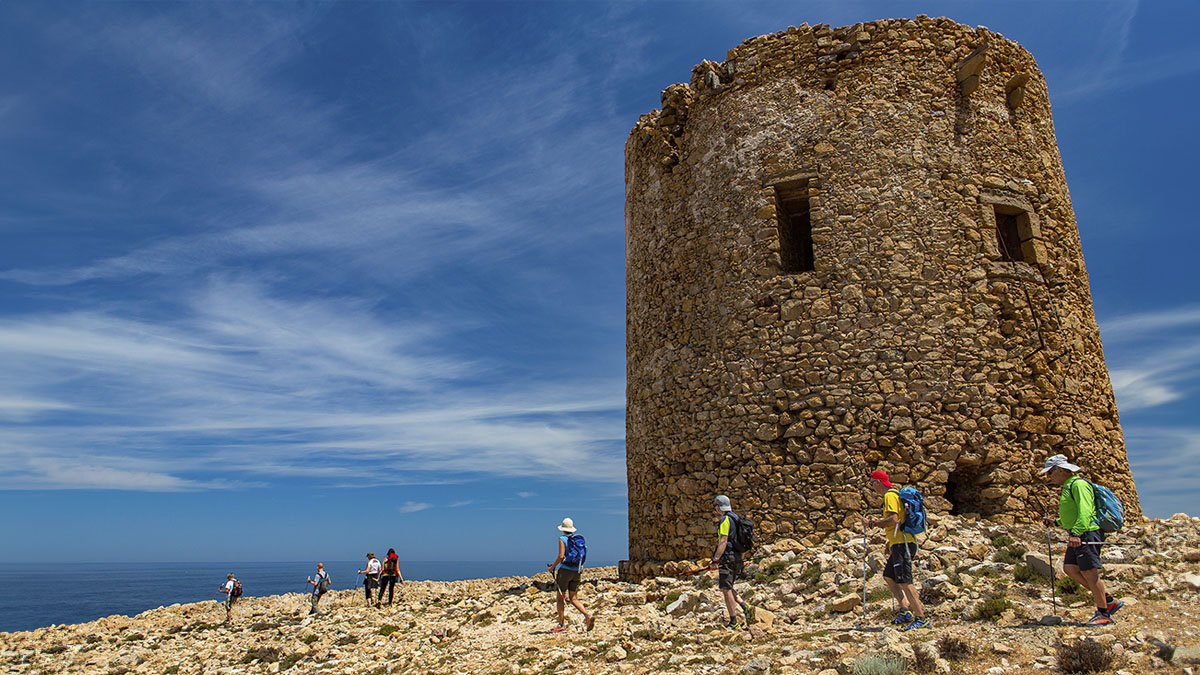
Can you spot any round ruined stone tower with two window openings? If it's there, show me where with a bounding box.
[622,17,1140,577]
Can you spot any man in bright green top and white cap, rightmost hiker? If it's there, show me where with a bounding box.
[1042,455,1124,626]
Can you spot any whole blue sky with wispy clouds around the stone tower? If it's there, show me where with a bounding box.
[0,1,1200,562]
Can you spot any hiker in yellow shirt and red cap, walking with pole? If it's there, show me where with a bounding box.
[863,471,929,631]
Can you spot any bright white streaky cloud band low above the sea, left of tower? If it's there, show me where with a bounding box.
[0,282,624,490]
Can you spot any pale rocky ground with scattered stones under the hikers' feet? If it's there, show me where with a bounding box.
[0,514,1200,675]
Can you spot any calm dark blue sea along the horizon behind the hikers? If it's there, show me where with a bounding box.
[0,561,600,631]
